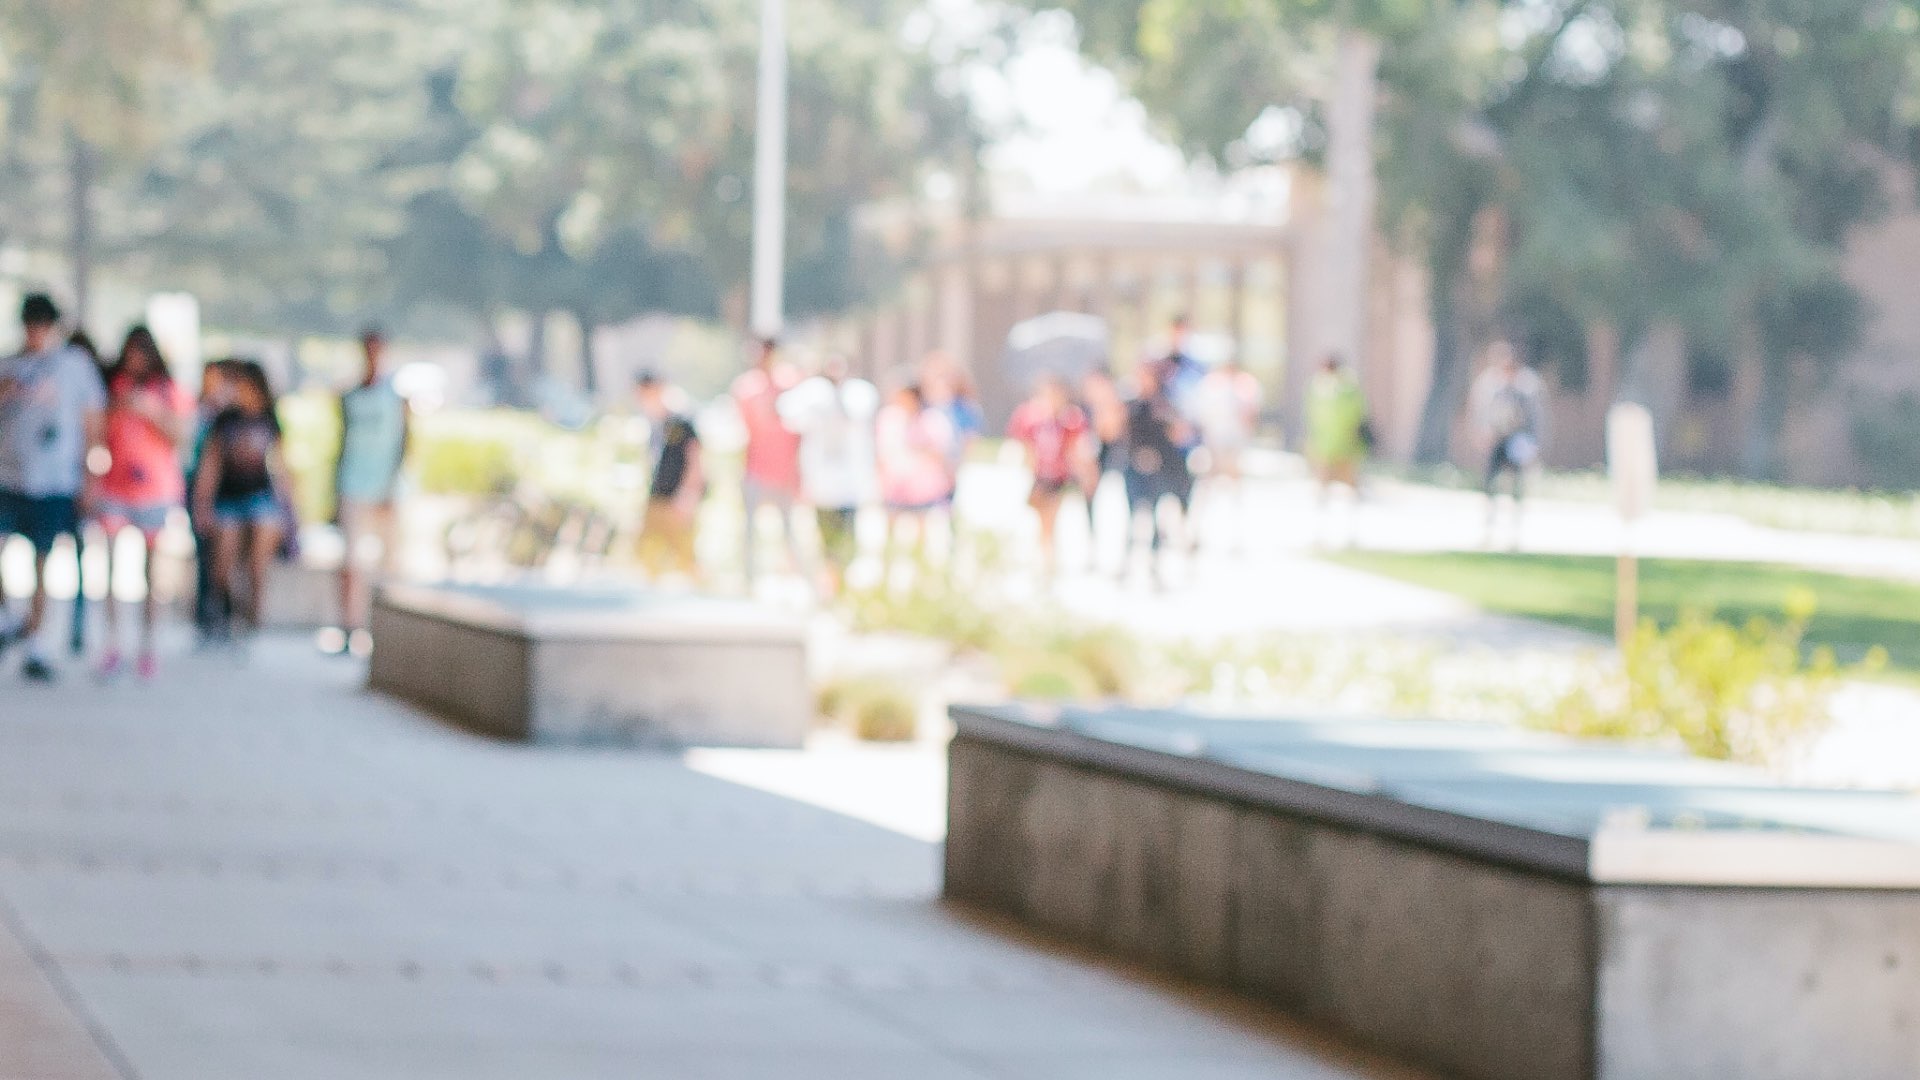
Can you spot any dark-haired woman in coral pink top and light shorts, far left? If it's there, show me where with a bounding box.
[94,327,194,678]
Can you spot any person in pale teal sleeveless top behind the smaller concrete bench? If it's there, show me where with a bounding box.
[334,329,411,655]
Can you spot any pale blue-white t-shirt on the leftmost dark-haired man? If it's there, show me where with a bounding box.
[0,346,108,498]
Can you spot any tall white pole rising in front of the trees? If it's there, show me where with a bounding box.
[749,0,787,338]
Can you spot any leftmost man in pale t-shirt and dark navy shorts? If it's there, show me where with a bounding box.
[0,292,106,682]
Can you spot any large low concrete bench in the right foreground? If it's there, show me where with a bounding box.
[947,707,1920,1080]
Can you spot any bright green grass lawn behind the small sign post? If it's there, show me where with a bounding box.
[1336,552,1920,676]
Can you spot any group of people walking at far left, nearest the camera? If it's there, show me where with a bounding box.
[0,294,405,682]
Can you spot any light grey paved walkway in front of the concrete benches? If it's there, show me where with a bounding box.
[0,640,1407,1080]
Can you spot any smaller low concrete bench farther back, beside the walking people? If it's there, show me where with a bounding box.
[369,586,812,748]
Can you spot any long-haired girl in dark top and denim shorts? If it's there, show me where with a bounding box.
[194,359,294,636]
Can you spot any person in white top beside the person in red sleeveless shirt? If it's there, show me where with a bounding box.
[780,356,879,598]
